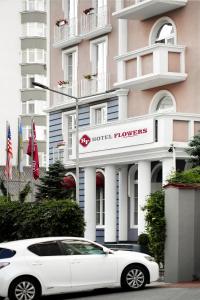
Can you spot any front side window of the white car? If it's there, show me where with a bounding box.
[61,240,105,255]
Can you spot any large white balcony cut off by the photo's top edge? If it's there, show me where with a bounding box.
[113,0,188,20]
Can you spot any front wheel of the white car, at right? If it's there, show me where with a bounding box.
[121,264,147,290]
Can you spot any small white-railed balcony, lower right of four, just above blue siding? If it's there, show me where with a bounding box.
[79,73,110,97]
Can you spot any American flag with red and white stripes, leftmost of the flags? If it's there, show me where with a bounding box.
[5,122,13,179]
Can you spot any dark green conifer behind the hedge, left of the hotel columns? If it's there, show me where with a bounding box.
[36,161,72,200]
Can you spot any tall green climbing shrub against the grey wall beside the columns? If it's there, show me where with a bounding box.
[144,190,166,264]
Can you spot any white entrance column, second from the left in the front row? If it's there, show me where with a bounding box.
[104,166,117,242]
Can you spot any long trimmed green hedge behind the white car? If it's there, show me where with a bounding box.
[0,200,85,242]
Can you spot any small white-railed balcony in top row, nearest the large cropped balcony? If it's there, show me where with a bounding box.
[81,6,112,39]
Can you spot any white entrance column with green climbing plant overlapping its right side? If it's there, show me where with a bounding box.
[138,161,151,235]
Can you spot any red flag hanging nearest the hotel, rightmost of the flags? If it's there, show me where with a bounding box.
[26,120,39,179]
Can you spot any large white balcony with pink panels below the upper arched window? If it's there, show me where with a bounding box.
[114,44,187,91]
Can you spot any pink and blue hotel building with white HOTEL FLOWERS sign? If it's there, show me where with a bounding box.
[48,0,200,242]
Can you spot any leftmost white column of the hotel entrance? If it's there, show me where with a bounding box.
[84,167,96,241]
